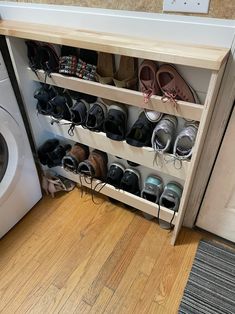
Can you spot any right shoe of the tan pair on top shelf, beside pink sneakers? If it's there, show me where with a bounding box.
[113,56,138,90]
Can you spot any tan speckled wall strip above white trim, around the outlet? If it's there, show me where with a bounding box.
[6,0,235,19]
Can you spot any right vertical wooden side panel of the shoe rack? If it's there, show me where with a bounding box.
[171,62,226,245]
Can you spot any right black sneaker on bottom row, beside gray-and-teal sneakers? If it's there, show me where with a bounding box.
[120,169,140,196]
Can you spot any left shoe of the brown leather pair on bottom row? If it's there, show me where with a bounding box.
[62,143,89,173]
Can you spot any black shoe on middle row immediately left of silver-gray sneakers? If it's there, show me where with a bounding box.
[126,111,156,147]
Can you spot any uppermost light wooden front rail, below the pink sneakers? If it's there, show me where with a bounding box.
[27,68,203,121]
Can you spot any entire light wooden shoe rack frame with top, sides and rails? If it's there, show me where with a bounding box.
[0,21,229,244]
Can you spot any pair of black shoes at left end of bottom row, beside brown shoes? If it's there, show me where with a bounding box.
[38,139,71,168]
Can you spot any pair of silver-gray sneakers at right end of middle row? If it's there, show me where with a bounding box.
[151,115,198,160]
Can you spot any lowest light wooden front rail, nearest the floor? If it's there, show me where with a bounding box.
[52,167,177,224]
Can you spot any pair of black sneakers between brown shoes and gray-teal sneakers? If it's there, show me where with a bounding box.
[106,163,140,196]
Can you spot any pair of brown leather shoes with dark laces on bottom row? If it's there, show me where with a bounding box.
[62,143,108,180]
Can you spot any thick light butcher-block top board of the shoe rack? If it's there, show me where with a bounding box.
[0,20,229,70]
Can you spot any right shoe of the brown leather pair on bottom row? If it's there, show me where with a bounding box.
[78,149,108,180]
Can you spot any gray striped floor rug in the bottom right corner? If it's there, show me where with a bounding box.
[179,240,235,314]
